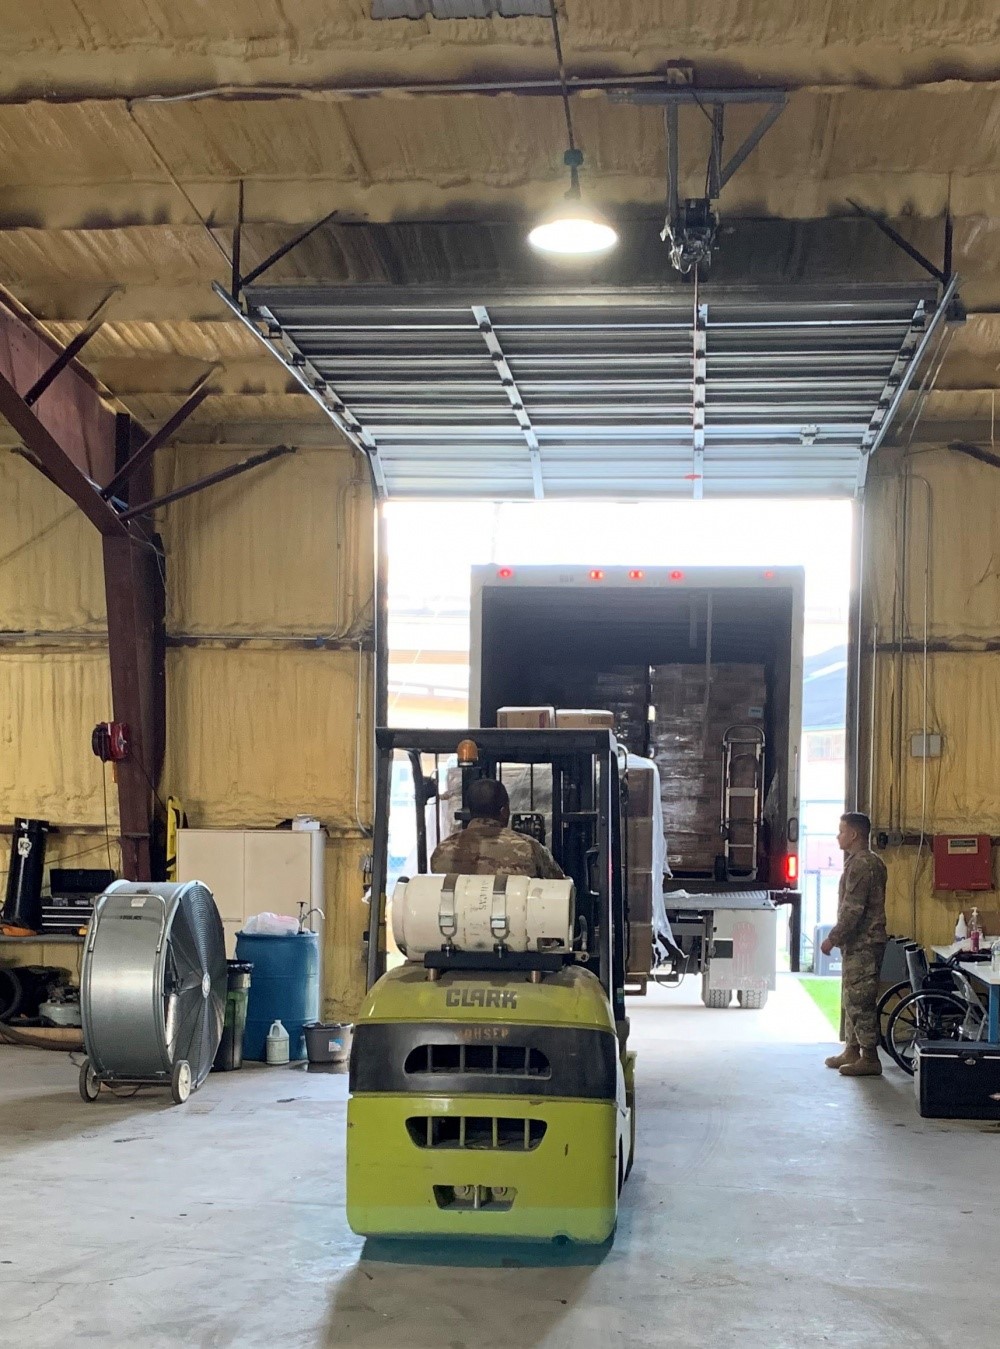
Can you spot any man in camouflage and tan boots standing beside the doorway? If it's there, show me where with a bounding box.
[821,812,885,1078]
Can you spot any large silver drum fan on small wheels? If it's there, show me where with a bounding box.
[80,881,225,1105]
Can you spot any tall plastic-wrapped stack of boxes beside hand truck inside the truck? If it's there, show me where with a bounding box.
[650,664,767,876]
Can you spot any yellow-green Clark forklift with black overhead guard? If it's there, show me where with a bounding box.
[347,730,634,1242]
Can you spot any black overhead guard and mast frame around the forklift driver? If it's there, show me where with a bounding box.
[367,727,628,1025]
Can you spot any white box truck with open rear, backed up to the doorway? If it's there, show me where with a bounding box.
[470,565,804,1008]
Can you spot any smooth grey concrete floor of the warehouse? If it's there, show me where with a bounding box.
[0,977,1000,1349]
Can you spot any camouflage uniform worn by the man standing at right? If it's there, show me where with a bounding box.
[830,849,885,1050]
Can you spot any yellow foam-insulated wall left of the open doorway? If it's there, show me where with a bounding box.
[0,447,374,1018]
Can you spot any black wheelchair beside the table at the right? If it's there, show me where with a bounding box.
[879,942,987,1077]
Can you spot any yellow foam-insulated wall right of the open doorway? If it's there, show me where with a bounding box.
[858,448,1000,944]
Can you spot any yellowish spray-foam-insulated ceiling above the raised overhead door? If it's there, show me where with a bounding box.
[0,0,1000,494]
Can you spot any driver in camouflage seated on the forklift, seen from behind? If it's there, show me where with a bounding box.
[430,777,563,881]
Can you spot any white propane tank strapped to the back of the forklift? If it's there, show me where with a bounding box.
[393,876,575,960]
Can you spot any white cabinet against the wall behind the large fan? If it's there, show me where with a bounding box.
[177,830,327,955]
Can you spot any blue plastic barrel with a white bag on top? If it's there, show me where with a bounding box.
[236,932,320,1063]
